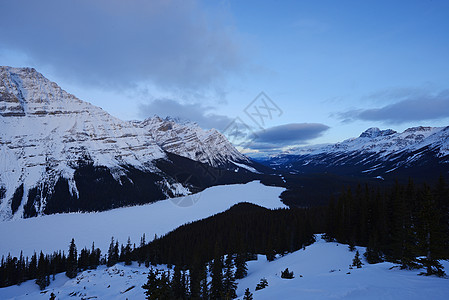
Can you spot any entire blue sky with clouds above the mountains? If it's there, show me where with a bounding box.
[0,0,449,155]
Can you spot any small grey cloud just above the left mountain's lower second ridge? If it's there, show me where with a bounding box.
[139,99,232,130]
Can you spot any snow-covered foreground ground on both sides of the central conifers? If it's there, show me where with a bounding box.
[0,238,449,300]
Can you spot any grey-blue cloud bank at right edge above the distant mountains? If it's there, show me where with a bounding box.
[337,90,449,124]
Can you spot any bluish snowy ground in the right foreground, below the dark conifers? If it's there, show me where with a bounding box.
[237,238,449,300]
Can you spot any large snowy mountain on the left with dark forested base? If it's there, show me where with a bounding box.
[0,67,256,220]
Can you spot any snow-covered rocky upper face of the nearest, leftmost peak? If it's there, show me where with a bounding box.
[0,67,165,218]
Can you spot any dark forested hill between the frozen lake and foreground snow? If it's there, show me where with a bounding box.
[134,203,326,266]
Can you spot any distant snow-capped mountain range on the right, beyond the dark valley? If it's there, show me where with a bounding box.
[261,126,449,179]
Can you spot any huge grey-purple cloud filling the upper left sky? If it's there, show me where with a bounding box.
[0,0,243,90]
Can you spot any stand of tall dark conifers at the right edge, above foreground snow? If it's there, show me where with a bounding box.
[326,177,449,276]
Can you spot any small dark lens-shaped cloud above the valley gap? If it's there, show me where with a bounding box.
[250,123,329,151]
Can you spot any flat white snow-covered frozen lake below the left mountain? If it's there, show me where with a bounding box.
[0,181,286,256]
